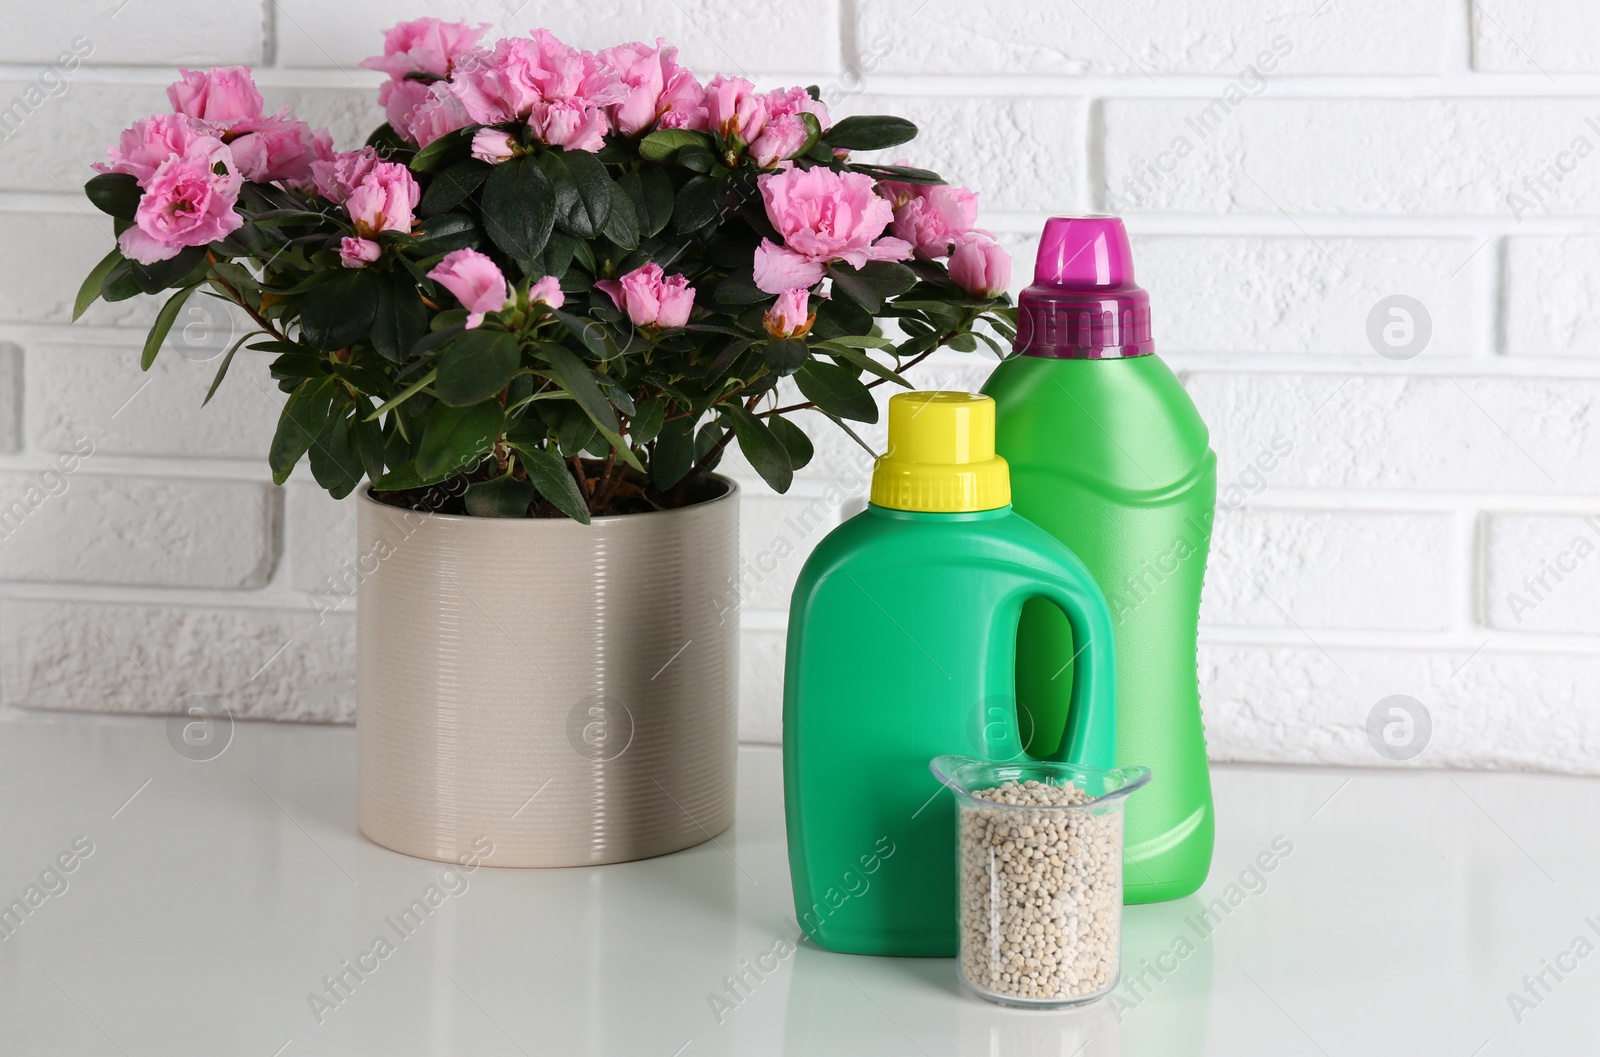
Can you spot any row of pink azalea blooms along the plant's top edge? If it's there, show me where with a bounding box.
[362,19,827,168]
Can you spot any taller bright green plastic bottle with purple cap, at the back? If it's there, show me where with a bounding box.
[984,217,1216,903]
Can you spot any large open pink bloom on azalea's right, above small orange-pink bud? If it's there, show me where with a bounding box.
[755,166,912,294]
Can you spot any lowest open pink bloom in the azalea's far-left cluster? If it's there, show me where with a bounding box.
[117,136,245,264]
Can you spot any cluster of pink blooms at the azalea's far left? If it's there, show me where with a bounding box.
[94,66,333,264]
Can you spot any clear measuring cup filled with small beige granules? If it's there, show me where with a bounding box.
[928,756,1150,1007]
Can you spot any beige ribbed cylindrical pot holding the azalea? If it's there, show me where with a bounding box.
[355,477,739,867]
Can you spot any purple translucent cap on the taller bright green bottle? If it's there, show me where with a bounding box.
[1013,216,1155,360]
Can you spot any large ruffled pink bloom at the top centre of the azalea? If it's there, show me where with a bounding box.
[450,29,627,139]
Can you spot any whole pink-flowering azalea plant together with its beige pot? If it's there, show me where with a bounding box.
[77,19,1016,865]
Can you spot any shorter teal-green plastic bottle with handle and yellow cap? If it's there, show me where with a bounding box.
[784,392,1115,956]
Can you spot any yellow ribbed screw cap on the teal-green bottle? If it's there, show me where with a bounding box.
[872,392,1011,513]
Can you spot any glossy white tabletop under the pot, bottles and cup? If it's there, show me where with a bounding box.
[0,720,1600,1057]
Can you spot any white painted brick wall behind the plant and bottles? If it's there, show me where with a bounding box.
[0,0,1600,772]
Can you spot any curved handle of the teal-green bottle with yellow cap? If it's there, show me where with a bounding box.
[1013,564,1117,771]
